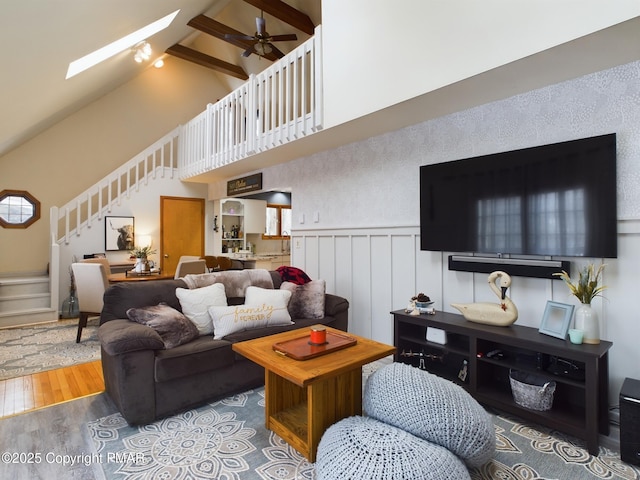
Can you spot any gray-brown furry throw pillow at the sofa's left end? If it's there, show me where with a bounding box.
[127,303,200,349]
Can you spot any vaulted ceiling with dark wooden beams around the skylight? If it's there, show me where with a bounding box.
[0,0,321,156]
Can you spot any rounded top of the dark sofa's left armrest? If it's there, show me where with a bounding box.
[98,320,164,355]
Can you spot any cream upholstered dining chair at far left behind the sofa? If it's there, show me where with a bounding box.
[71,262,109,343]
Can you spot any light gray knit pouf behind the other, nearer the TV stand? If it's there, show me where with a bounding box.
[362,363,496,467]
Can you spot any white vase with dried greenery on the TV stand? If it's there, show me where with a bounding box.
[554,263,607,344]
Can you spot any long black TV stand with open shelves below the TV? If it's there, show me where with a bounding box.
[391,310,612,455]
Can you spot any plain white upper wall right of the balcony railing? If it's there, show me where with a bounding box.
[322,0,640,128]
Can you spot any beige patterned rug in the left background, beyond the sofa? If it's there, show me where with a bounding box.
[0,318,100,380]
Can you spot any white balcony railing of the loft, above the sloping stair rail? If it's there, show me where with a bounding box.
[178,26,323,180]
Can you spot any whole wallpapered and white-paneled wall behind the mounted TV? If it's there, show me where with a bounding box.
[263,62,640,403]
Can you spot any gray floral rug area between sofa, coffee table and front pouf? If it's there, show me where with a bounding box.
[88,389,314,480]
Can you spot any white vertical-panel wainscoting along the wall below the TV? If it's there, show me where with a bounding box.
[291,220,640,404]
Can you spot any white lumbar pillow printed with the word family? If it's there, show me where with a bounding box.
[209,302,293,340]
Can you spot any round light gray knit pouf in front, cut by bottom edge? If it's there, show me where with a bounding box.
[315,416,470,480]
